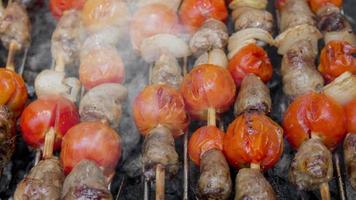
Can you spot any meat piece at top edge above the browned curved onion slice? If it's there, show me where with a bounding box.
[279,0,316,32]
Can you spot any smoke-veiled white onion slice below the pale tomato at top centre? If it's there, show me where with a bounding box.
[140,34,191,63]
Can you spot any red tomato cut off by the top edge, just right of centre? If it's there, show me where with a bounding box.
[179,0,228,32]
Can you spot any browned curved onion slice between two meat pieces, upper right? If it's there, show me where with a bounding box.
[275,24,322,55]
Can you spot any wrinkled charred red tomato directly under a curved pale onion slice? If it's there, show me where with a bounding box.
[228,44,273,88]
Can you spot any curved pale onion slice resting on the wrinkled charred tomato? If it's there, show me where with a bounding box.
[228,28,275,59]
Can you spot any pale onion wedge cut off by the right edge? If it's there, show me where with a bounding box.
[323,72,356,105]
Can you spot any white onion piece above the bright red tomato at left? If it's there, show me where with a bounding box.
[35,70,80,102]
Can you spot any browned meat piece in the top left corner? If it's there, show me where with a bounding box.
[0,2,31,50]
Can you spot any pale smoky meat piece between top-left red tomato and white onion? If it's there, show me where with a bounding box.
[51,10,84,64]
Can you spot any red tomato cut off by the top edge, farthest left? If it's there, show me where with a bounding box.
[49,0,86,19]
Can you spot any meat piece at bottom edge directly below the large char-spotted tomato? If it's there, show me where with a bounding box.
[234,168,276,200]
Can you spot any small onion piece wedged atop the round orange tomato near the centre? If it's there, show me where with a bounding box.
[194,49,229,68]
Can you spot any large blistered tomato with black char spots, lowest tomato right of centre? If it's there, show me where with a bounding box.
[224,112,283,170]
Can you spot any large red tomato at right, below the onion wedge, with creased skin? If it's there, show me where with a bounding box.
[283,92,346,149]
